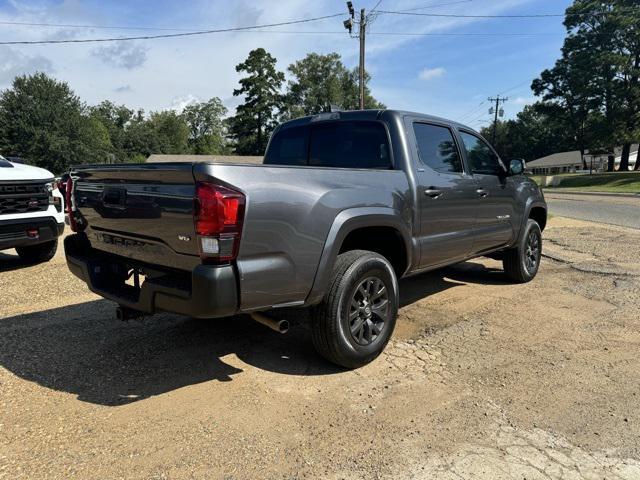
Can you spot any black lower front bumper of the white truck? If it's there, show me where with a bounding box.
[0,217,64,250]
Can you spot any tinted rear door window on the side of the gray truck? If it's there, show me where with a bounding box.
[413,123,462,173]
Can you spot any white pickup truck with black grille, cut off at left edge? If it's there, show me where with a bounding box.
[0,156,64,263]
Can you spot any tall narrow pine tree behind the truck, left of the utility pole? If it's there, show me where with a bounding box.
[228,48,284,155]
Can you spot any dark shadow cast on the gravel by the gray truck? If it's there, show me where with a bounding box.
[0,258,510,406]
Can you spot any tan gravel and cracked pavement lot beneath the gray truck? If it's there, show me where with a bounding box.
[0,218,640,479]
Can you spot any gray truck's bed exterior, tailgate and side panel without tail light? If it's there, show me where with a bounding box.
[72,163,412,311]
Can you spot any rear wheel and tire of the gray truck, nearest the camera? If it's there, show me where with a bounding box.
[311,250,399,368]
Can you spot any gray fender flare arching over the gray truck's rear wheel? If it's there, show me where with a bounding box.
[305,207,412,305]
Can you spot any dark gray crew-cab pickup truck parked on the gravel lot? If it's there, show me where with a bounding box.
[65,110,547,368]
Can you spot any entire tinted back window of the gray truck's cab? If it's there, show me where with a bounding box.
[264,121,391,169]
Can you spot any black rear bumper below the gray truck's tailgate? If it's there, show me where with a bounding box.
[64,235,238,318]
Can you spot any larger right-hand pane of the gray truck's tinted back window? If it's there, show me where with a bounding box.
[309,122,391,169]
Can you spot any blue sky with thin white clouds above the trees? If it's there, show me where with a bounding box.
[0,0,571,128]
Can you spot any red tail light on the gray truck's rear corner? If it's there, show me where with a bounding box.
[194,182,245,263]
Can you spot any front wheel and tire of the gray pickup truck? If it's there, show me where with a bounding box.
[502,219,542,283]
